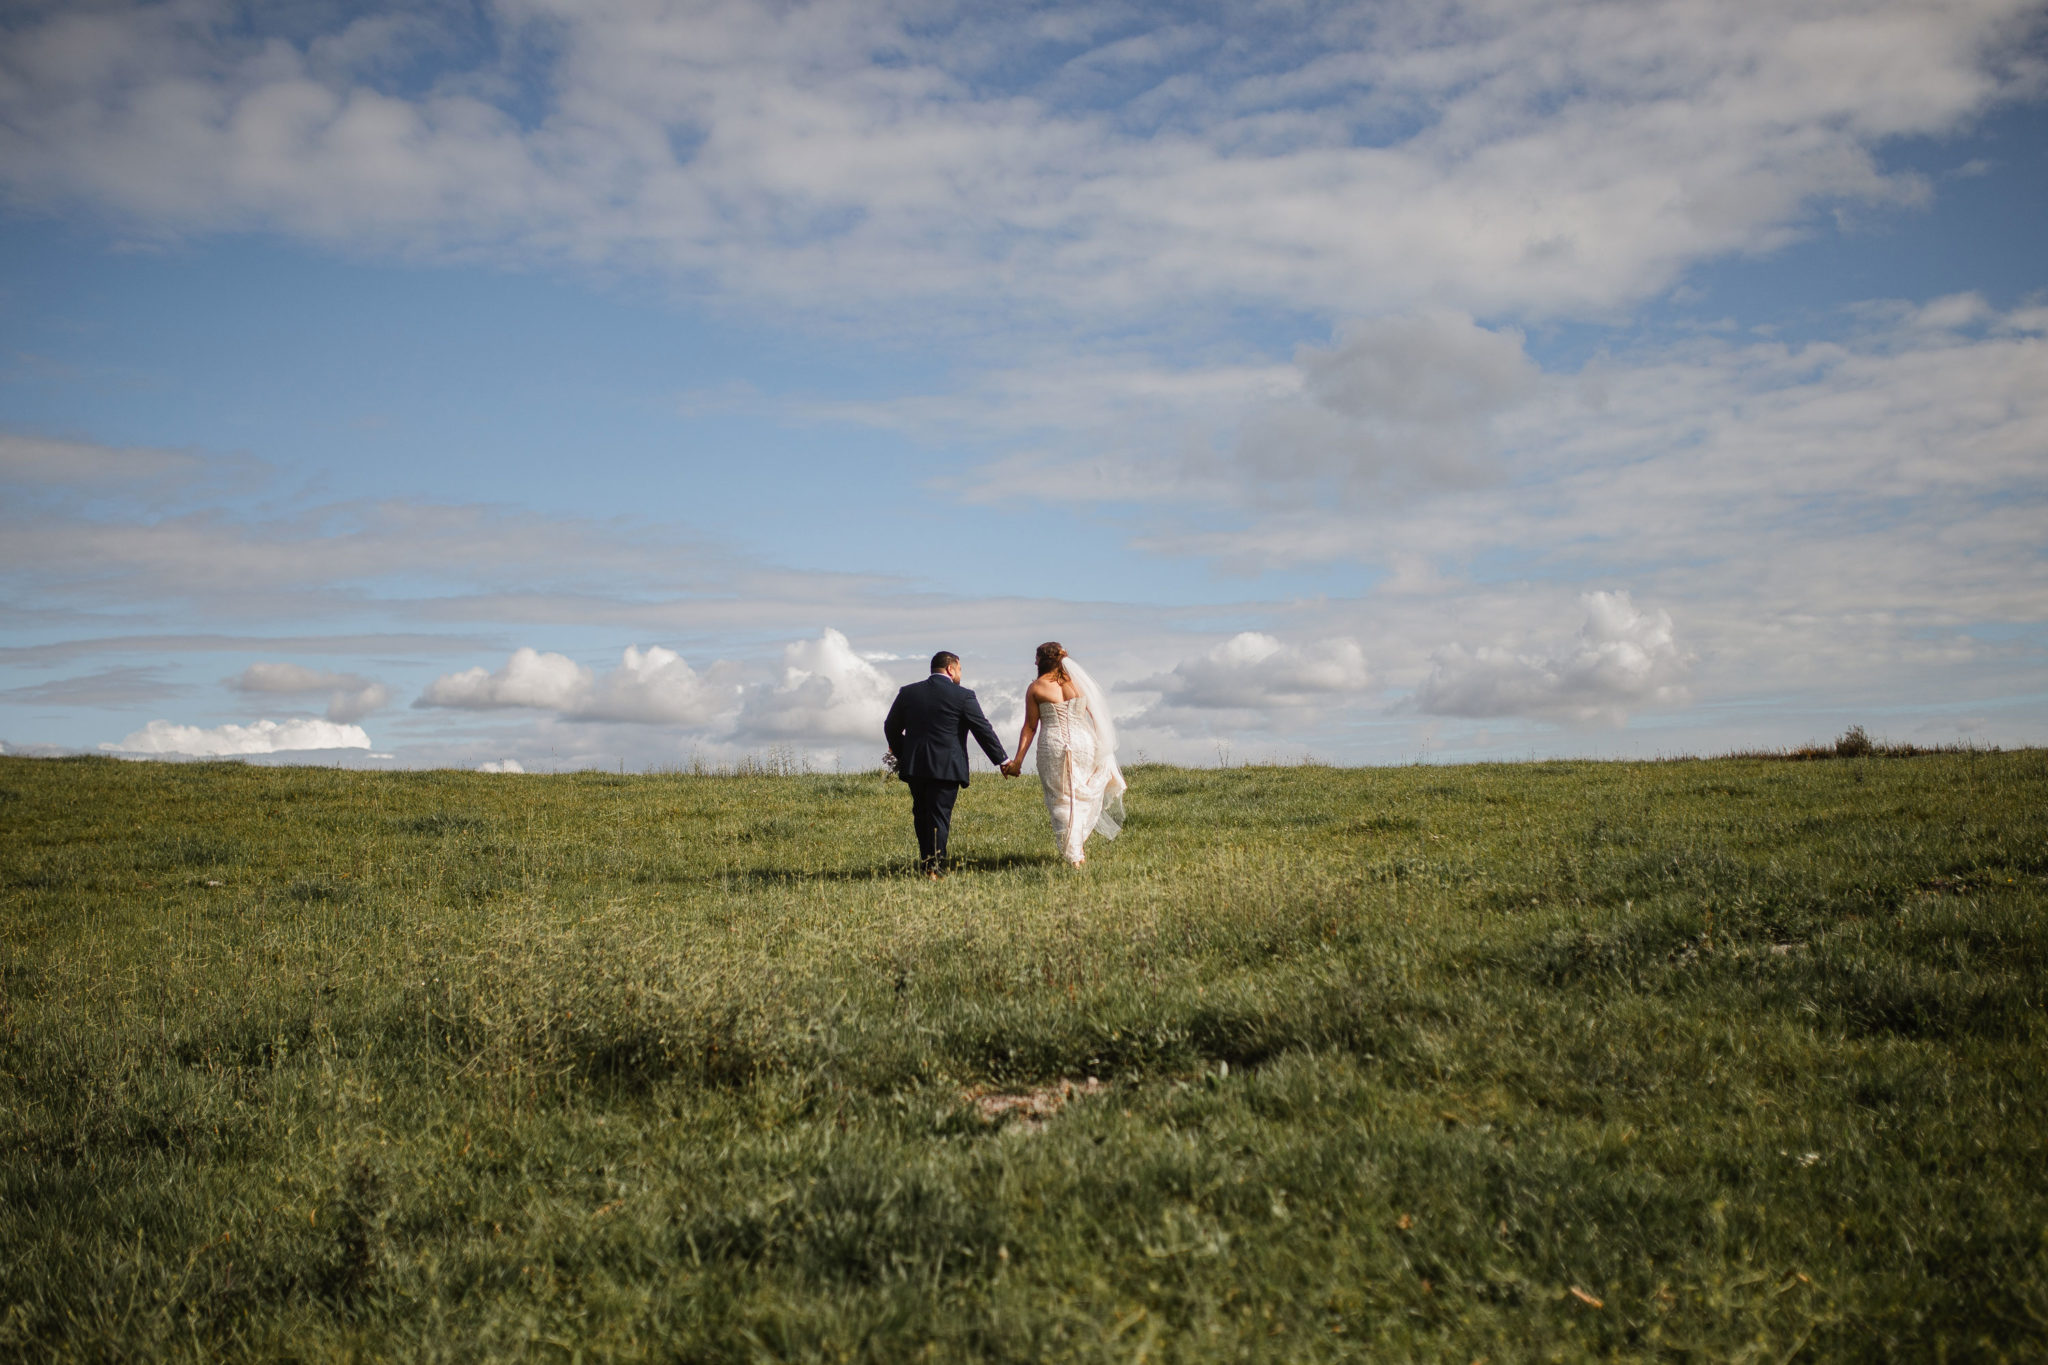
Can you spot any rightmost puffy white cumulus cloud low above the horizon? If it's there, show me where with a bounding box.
[1413,591,1692,724]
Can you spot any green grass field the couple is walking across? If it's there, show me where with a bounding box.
[0,751,2048,1363]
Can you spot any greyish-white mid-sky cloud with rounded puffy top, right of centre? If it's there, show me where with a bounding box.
[942,309,1542,508]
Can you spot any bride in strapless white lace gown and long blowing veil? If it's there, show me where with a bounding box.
[1004,641,1124,868]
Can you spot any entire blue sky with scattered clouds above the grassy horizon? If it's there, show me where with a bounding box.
[0,0,2048,767]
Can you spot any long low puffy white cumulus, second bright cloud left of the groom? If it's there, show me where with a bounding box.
[414,645,739,724]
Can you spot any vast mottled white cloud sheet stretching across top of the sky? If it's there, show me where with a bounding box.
[0,0,2040,325]
